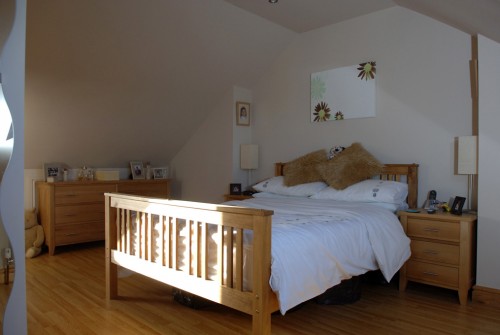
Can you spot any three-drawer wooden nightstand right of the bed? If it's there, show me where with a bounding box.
[398,210,477,305]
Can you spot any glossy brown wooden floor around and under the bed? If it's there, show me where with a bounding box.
[17,243,500,335]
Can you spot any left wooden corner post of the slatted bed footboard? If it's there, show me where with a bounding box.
[104,193,118,302]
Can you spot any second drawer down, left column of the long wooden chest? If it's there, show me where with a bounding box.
[55,202,104,226]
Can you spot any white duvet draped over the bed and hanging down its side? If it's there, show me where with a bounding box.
[225,197,410,314]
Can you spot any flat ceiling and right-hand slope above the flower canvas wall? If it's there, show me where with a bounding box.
[225,0,500,42]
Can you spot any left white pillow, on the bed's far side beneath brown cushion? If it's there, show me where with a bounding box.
[253,176,328,197]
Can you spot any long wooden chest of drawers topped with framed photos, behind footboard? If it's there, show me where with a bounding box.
[36,179,170,255]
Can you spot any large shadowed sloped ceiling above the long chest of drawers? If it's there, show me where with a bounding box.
[25,0,296,168]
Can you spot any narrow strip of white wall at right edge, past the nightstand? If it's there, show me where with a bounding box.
[477,36,500,289]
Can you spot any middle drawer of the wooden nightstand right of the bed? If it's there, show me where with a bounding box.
[410,240,460,265]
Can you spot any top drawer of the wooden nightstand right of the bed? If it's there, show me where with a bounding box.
[406,218,460,243]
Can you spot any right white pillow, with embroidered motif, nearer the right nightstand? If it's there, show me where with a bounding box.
[311,179,408,205]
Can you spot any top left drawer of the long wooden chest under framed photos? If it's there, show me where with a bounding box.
[54,184,116,206]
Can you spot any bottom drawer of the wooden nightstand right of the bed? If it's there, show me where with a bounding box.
[406,259,458,288]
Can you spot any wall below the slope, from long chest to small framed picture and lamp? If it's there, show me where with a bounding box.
[170,86,254,203]
